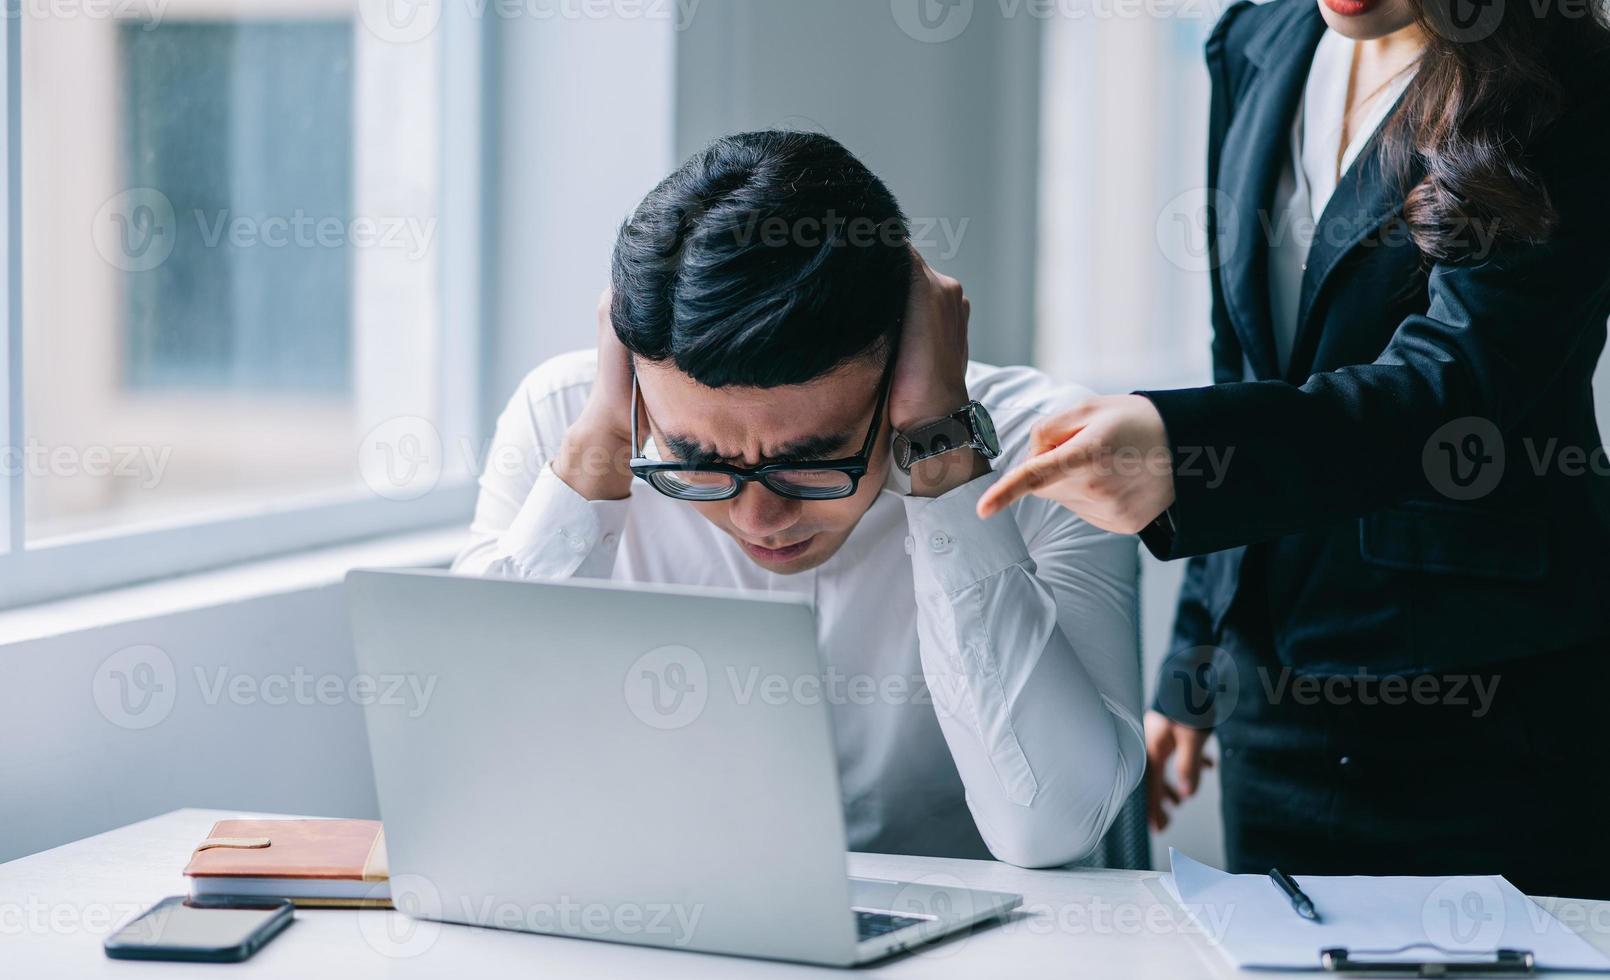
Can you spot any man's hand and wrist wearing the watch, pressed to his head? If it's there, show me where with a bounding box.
[889,248,990,497]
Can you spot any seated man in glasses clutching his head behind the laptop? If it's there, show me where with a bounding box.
[454,132,1143,867]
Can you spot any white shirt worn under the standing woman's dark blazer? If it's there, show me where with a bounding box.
[1268,31,1415,375]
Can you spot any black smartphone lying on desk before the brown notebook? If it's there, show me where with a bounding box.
[106,895,293,962]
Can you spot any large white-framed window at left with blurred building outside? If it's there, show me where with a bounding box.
[0,0,480,607]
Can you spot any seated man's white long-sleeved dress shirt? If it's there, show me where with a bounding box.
[454,351,1145,866]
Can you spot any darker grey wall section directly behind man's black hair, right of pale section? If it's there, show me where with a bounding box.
[676,0,1040,364]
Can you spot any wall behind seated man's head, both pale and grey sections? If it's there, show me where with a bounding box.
[483,0,1040,384]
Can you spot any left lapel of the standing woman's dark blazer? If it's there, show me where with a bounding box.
[1214,3,1325,378]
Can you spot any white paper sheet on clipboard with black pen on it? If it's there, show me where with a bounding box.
[1169,848,1610,970]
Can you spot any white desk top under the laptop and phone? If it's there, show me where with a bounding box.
[9,809,1610,980]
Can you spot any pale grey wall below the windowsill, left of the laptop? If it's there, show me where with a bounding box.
[0,584,377,861]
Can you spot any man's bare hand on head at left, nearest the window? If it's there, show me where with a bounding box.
[554,288,636,500]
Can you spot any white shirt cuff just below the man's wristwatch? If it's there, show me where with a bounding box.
[903,473,1032,595]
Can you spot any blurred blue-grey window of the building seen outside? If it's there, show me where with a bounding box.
[118,19,353,394]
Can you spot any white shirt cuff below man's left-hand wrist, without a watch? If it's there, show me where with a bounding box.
[502,465,631,578]
